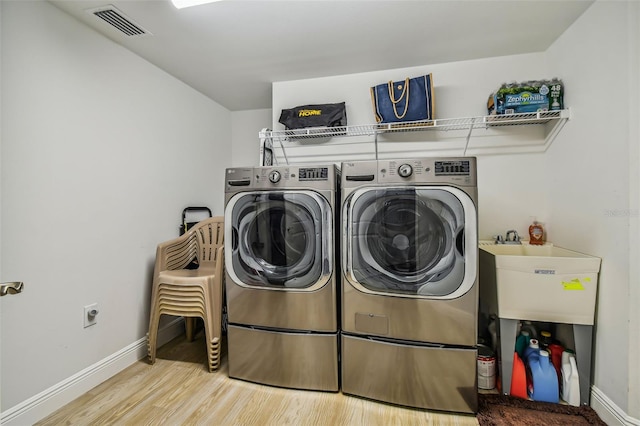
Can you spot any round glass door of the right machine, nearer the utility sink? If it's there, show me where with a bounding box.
[343,186,477,299]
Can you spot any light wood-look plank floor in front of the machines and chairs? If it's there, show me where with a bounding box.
[37,333,478,426]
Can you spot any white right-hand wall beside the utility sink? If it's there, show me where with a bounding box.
[545,1,640,419]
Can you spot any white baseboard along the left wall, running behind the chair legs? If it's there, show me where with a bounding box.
[0,318,184,426]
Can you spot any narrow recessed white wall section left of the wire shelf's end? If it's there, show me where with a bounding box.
[228,109,271,167]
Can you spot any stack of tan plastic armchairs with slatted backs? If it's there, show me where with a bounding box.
[147,216,224,371]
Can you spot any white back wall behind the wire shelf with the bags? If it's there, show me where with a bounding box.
[273,53,555,239]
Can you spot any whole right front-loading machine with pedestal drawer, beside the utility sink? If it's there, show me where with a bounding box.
[341,157,478,413]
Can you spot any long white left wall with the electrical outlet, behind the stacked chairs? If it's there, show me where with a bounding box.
[0,1,232,418]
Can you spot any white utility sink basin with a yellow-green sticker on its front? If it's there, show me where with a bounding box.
[479,242,600,325]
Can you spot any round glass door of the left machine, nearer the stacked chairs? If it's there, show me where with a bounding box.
[225,191,333,290]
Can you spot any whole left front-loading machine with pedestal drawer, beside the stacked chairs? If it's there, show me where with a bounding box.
[225,165,340,392]
